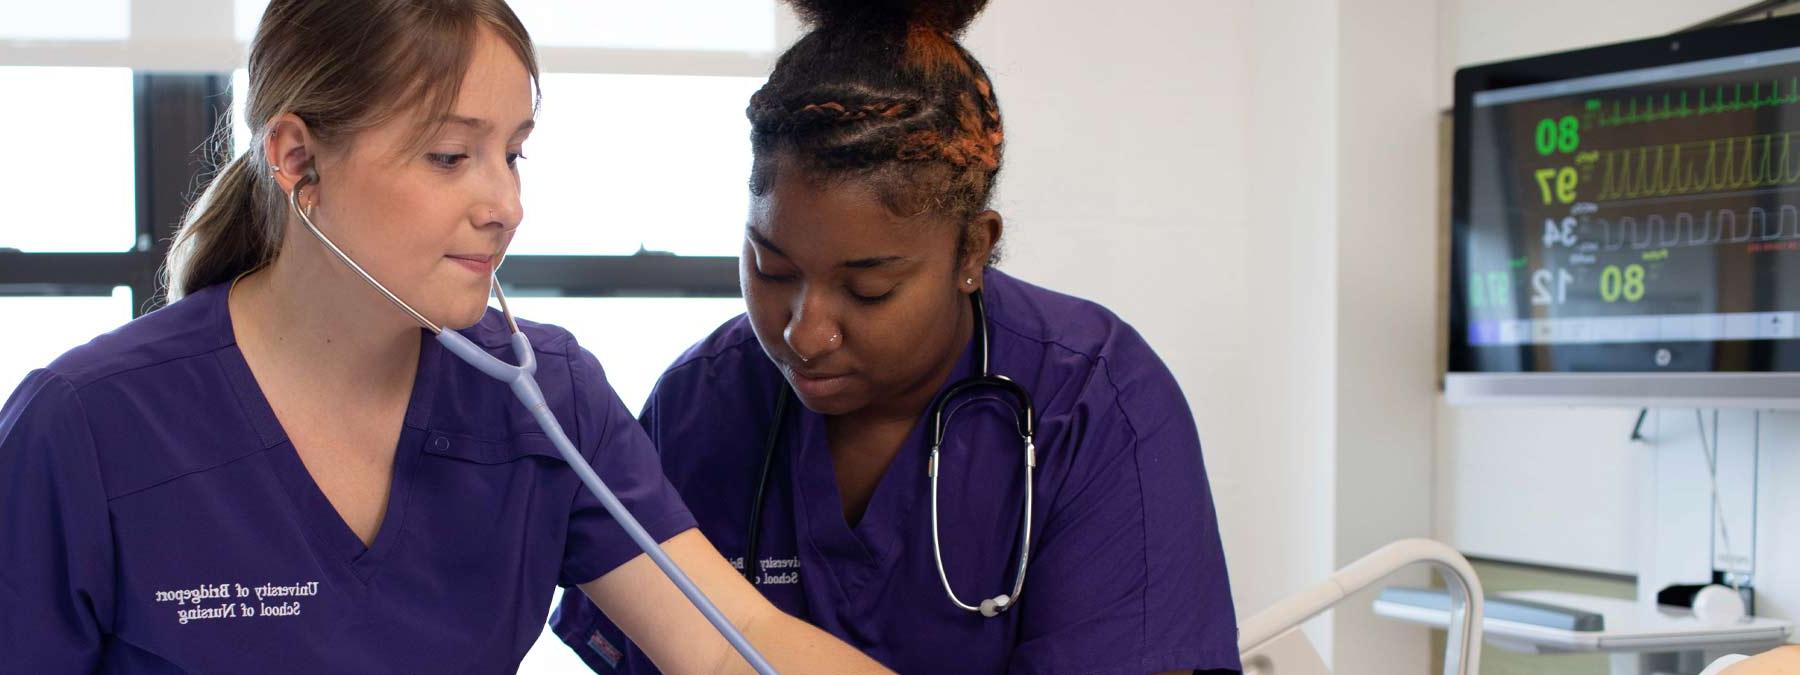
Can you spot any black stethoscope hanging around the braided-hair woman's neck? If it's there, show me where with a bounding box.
[743,290,1037,617]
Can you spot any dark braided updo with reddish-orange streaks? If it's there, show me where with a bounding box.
[747,0,1004,262]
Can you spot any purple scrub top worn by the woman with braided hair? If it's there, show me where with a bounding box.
[553,270,1240,673]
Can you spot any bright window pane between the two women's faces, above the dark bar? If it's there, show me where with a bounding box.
[513,74,761,256]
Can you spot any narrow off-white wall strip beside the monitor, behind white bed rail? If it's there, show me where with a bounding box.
[1332,0,1440,673]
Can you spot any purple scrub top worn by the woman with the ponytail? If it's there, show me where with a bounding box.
[0,286,693,673]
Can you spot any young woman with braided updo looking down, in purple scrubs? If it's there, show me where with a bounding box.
[554,0,1240,673]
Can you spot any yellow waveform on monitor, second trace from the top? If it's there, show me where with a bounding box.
[1593,131,1800,202]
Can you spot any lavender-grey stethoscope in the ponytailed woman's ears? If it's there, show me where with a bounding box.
[288,169,776,675]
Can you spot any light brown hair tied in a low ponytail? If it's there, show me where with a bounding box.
[164,0,538,302]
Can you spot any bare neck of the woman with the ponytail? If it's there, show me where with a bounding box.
[229,248,419,400]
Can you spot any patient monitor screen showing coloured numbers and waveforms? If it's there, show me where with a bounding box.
[1453,49,1800,373]
